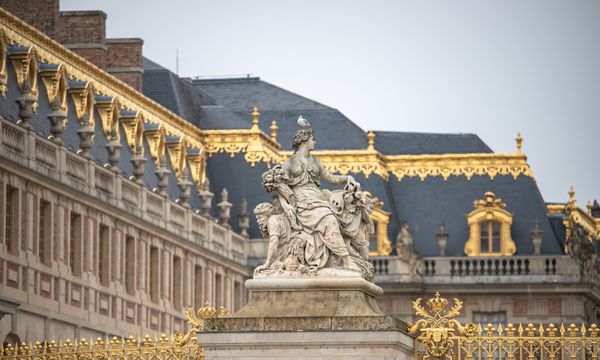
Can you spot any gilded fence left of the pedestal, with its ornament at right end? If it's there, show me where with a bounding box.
[0,302,228,360]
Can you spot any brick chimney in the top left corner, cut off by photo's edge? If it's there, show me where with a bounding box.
[0,0,60,39]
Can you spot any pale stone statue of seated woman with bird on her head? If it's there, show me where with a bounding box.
[254,118,374,281]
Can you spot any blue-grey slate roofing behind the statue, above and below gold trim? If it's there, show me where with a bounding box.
[134,57,576,256]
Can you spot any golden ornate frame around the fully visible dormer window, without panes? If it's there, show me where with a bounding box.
[465,191,517,256]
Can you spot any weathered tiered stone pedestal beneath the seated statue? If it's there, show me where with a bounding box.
[198,270,414,359]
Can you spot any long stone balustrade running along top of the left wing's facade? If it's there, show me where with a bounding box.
[0,119,249,265]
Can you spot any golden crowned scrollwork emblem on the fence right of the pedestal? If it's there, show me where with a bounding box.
[407,292,475,359]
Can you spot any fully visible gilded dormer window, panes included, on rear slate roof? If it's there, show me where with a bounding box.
[465,192,516,256]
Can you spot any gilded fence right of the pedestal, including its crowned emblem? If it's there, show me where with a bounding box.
[408,293,600,360]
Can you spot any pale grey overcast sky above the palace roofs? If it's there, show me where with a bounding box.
[60,0,600,207]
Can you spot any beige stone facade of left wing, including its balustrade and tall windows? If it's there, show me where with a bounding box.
[0,119,249,341]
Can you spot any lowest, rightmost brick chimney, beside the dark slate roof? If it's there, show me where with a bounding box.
[106,38,144,92]
